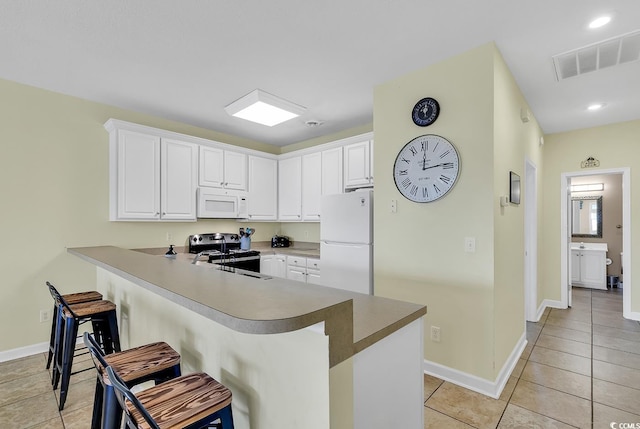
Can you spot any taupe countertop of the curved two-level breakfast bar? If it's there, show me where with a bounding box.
[68,246,427,366]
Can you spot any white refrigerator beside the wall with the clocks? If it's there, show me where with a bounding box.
[320,189,373,295]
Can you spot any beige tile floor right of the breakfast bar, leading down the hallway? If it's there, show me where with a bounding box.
[424,288,640,429]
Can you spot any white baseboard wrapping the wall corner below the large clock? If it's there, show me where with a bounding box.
[424,332,527,399]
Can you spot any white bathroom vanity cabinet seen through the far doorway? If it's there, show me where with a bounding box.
[571,243,608,290]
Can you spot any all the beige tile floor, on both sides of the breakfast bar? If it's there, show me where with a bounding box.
[0,289,640,429]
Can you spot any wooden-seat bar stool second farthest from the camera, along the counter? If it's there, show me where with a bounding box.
[49,286,120,411]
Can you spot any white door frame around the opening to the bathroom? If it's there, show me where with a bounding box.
[560,168,637,319]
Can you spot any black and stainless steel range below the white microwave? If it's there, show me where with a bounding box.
[189,232,260,273]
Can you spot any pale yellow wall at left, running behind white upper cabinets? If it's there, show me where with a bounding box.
[0,80,288,351]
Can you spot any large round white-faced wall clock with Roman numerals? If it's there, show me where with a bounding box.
[393,134,460,203]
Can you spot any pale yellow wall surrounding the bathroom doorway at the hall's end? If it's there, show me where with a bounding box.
[541,120,640,313]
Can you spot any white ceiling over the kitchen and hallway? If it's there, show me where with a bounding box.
[0,0,640,146]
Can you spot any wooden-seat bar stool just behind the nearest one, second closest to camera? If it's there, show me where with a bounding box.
[84,332,180,429]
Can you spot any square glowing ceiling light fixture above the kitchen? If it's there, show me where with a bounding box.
[224,89,307,127]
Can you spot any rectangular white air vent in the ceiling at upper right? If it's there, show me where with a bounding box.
[553,30,640,81]
